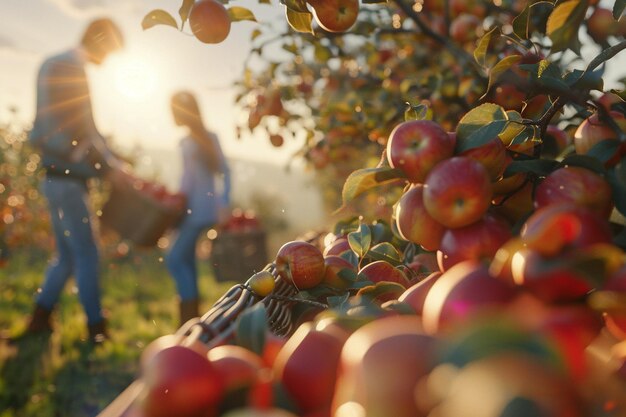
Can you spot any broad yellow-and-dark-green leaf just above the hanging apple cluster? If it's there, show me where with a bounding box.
[455,103,508,153]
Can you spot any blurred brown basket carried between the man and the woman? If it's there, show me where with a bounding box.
[100,183,184,247]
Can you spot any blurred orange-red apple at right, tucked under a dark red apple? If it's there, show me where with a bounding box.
[520,204,612,256]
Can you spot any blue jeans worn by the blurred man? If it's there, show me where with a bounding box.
[37,176,103,325]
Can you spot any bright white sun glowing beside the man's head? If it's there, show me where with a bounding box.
[110,53,159,101]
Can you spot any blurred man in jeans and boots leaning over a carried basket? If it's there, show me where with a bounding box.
[21,18,123,343]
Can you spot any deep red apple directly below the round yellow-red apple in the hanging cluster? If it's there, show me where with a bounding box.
[437,214,511,271]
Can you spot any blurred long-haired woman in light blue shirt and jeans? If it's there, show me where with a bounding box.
[165,91,231,325]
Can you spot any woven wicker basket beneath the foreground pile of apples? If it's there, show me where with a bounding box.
[97,264,298,417]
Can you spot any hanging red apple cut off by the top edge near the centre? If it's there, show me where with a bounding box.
[307,0,359,32]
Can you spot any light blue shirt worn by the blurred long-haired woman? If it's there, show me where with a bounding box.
[180,134,231,226]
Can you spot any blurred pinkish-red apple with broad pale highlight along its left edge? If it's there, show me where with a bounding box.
[422,260,516,334]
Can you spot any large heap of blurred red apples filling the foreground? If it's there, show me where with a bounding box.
[133,223,626,417]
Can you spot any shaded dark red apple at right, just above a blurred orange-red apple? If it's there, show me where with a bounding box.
[534,166,613,219]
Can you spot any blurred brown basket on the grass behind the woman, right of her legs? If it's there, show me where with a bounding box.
[210,229,268,282]
